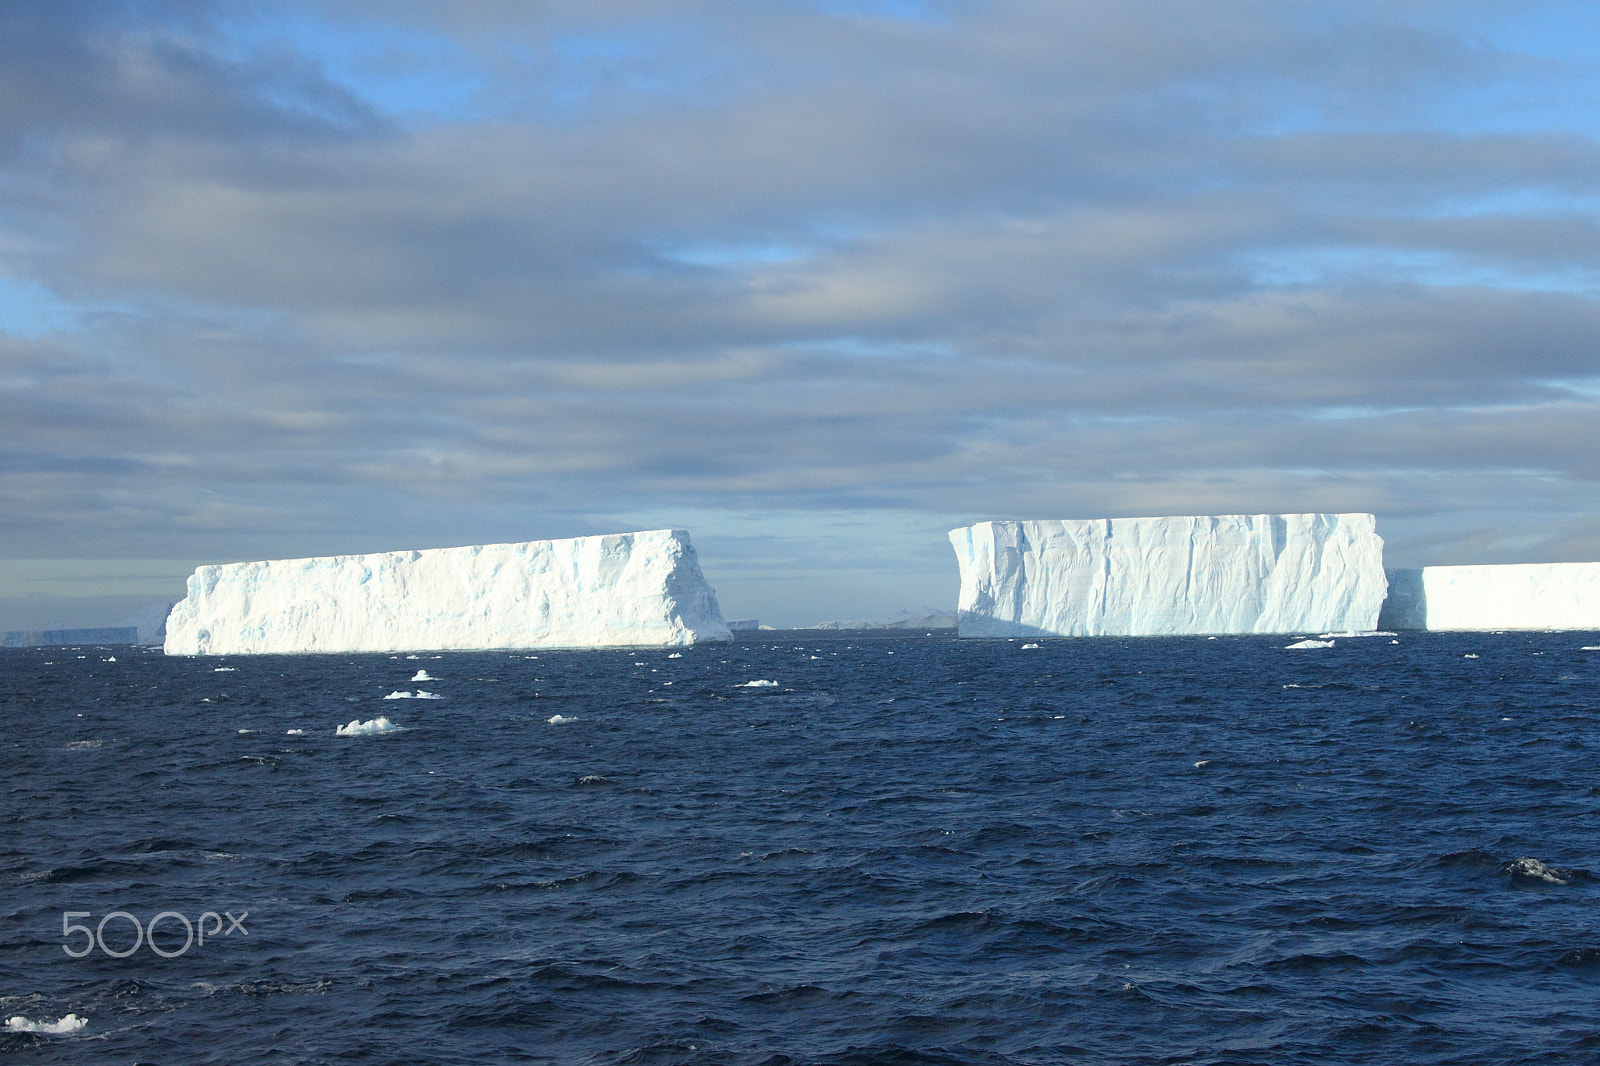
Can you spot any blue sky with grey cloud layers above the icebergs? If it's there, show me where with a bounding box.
[0,0,1600,627]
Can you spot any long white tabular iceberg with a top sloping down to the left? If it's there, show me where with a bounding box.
[165,530,731,655]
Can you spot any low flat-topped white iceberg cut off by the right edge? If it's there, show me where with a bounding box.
[1378,562,1600,629]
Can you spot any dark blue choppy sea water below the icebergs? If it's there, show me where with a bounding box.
[0,634,1600,1066]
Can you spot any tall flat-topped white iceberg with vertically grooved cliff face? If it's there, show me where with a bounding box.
[950,514,1387,637]
